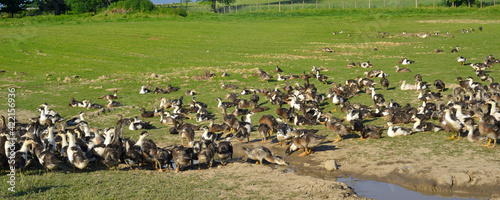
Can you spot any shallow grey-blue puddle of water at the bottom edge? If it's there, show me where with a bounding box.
[337,178,473,200]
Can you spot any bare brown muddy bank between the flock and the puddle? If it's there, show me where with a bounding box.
[229,142,500,199]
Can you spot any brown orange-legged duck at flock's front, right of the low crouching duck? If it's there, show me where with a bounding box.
[285,133,327,156]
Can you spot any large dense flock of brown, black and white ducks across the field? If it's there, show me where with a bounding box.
[0,28,500,172]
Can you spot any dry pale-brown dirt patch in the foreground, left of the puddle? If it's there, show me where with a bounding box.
[182,162,363,199]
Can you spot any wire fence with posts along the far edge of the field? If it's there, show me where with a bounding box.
[157,0,496,14]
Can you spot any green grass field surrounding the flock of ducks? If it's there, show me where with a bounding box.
[0,7,500,199]
